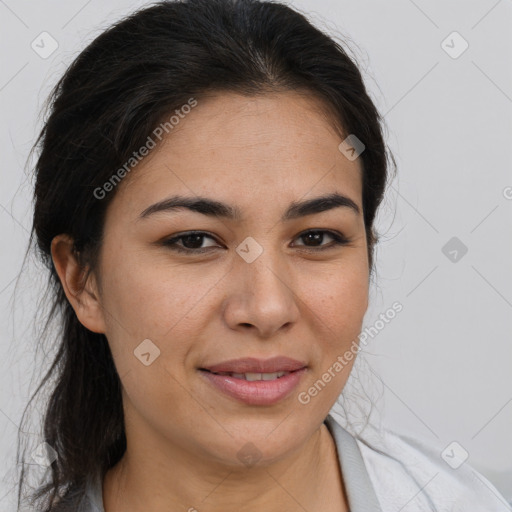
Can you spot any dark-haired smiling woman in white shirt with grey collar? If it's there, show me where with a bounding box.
[20,0,503,512]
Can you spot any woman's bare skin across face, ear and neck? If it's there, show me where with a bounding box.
[52,92,369,512]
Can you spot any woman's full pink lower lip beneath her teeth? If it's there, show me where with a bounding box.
[200,368,307,405]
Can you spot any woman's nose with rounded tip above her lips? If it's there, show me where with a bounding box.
[223,246,300,339]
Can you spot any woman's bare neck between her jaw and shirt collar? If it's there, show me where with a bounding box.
[103,423,348,512]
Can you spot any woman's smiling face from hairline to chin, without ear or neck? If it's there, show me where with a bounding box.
[90,93,369,465]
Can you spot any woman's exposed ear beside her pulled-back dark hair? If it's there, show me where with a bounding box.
[51,235,105,333]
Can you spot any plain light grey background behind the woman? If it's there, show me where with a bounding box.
[0,0,512,511]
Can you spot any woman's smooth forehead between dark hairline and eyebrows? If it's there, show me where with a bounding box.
[114,92,362,215]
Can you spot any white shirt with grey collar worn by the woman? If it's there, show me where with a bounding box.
[75,414,512,512]
